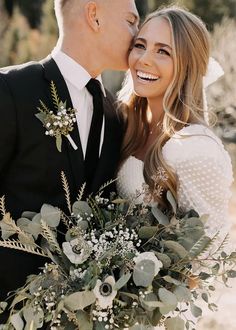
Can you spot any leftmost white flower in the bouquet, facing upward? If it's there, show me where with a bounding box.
[62,238,91,265]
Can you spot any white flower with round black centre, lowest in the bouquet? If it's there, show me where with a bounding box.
[93,276,117,309]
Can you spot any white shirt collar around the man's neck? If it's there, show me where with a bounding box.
[51,48,106,97]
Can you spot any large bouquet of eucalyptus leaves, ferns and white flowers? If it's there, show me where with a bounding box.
[0,176,236,330]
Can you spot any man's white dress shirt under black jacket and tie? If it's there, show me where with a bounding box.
[51,49,106,158]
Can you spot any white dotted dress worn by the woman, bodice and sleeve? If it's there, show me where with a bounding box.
[117,124,233,236]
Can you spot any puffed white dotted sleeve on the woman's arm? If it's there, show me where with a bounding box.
[165,131,233,235]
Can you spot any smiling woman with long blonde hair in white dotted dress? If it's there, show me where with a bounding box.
[117,7,233,242]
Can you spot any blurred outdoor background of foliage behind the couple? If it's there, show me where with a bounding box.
[0,0,236,330]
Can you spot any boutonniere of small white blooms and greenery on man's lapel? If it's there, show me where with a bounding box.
[35,81,78,152]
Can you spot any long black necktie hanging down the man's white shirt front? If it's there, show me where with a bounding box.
[85,79,103,193]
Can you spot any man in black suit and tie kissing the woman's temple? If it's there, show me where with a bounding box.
[0,0,138,312]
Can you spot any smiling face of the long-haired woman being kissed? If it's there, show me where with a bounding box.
[129,17,174,100]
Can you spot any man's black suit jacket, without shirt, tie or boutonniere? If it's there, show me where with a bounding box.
[0,57,123,301]
